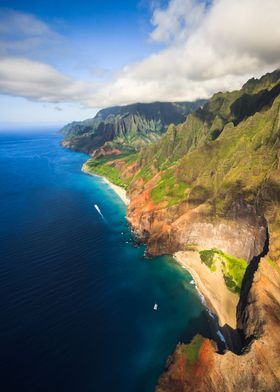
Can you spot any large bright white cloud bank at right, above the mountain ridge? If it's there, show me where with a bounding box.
[88,0,280,105]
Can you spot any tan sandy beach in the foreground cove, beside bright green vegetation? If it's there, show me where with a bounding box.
[174,251,239,329]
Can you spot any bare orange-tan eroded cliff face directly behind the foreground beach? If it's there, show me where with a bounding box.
[128,198,267,261]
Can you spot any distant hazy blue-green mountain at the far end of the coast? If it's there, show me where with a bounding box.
[61,100,205,153]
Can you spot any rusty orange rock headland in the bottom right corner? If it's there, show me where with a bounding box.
[157,259,280,392]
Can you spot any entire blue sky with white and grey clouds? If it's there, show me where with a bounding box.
[0,0,280,123]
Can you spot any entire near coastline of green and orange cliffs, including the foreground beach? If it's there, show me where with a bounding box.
[63,70,280,392]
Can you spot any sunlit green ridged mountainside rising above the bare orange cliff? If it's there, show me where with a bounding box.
[89,70,280,258]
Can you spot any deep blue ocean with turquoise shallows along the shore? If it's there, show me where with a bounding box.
[0,131,214,392]
